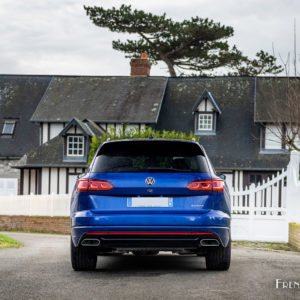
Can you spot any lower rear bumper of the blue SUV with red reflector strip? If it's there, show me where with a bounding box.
[72,226,230,250]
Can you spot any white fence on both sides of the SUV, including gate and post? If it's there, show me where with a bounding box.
[0,152,300,242]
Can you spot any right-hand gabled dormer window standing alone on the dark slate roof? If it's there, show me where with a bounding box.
[193,89,221,135]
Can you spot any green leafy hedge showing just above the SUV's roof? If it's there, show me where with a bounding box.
[88,126,197,166]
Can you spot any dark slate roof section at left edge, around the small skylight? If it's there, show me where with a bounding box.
[0,75,51,158]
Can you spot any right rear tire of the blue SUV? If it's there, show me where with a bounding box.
[205,241,231,271]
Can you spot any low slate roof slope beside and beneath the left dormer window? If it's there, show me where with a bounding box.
[14,136,86,168]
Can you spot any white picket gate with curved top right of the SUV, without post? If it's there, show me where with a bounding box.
[230,170,288,242]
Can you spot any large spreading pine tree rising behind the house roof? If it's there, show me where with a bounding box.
[84,4,282,77]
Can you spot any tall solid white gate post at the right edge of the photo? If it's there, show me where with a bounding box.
[286,151,300,223]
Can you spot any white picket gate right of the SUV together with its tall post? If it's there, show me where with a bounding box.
[230,152,300,242]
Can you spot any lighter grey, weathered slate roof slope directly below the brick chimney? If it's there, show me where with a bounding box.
[31,76,167,123]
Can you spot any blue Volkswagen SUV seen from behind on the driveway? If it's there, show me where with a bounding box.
[71,139,231,270]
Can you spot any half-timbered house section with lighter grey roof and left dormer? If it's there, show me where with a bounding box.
[13,76,167,194]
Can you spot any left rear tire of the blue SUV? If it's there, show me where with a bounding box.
[71,238,97,271]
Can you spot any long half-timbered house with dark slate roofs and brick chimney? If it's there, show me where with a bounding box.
[0,58,296,194]
